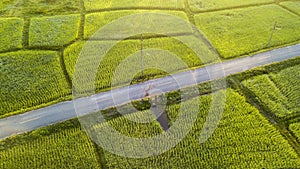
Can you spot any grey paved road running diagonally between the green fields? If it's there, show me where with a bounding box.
[0,44,300,139]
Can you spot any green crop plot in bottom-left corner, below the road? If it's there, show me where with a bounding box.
[0,122,101,169]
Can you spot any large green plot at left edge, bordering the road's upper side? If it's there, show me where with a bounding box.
[0,51,70,117]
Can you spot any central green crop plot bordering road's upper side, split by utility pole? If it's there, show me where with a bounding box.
[64,36,217,93]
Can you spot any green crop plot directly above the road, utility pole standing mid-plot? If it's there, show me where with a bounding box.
[64,36,217,89]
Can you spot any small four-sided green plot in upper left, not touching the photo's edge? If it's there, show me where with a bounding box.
[29,15,79,47]
